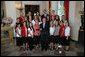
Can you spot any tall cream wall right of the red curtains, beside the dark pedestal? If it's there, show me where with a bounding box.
[69,1,82,41]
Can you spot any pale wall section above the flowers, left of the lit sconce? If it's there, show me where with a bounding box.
[5,1,16,27]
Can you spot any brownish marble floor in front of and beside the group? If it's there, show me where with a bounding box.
[1,40,84,56]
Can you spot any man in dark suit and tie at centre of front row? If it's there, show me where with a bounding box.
[40,18,49,50]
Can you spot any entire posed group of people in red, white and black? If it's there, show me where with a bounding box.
[14,10,70,51]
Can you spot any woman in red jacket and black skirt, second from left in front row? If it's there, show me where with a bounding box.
[21,22,28,51]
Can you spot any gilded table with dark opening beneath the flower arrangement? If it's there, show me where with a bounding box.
[1,27,13,41]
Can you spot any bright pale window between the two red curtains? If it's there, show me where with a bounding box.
[51,1,64,20]
